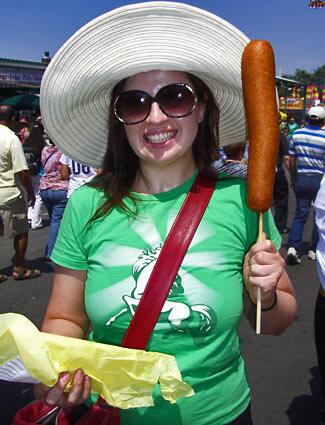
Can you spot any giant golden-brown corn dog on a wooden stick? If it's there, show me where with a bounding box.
[242,40,280,334]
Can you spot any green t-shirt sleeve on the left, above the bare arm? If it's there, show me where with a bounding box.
[51,192,88,270]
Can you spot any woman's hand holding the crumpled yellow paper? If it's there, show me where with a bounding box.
[34,369,90,408]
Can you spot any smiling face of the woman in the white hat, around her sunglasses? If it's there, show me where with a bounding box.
[123,71,205,171]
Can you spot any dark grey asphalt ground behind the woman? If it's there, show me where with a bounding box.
[0,190,321,425]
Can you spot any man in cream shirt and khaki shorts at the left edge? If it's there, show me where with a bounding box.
[0,105,41,281]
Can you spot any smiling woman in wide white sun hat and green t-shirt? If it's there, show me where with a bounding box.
[36,2,296,425]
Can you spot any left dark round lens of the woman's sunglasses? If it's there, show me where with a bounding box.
[115,90,151,124]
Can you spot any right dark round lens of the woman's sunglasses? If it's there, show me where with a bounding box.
[157,84,195,118]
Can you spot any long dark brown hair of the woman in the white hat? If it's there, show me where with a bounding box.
[89,74,219,222]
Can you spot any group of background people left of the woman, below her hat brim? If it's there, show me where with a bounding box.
[0,110,99,282]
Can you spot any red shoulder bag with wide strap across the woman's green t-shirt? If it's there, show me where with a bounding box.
[12,173,216,425]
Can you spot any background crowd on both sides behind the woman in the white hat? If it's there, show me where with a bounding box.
[0,99,325,424]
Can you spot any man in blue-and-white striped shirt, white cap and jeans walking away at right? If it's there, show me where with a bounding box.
[287,106,325,265]
